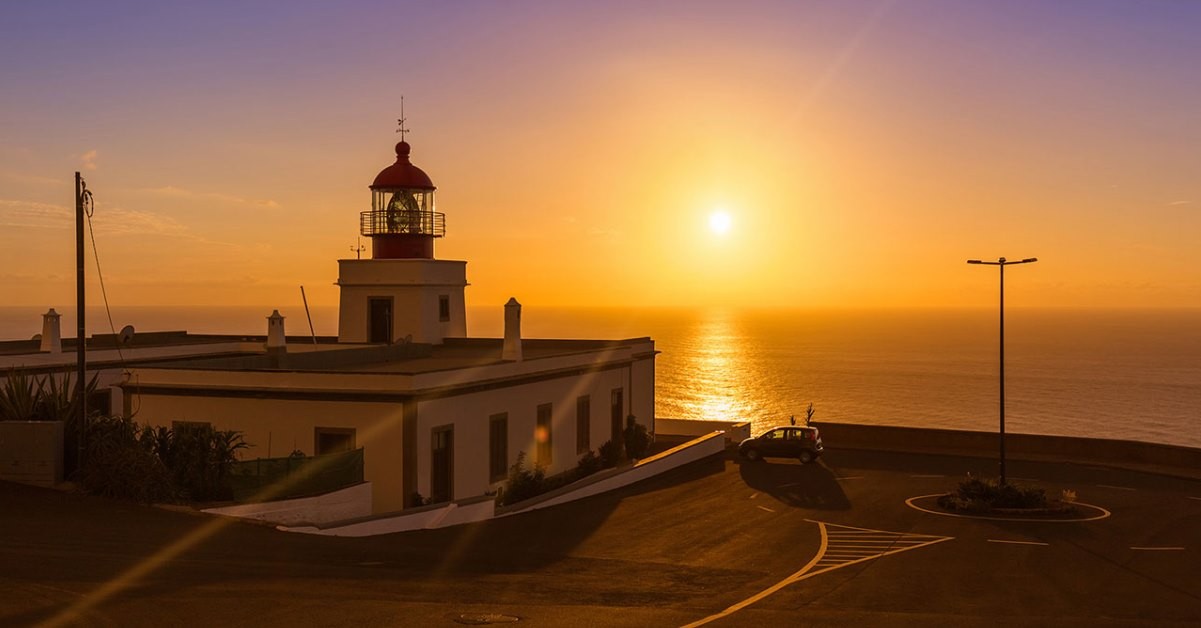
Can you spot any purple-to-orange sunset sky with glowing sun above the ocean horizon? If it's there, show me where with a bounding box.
[0,0,1201,307]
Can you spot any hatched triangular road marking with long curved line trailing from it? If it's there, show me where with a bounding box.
[683,519,955,628]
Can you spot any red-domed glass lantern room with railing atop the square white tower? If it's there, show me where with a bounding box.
[359,140,446,259]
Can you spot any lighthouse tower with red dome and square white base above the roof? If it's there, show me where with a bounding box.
[337,139,467,345]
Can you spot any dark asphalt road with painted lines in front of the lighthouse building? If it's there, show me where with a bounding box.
[0,449,1201,627]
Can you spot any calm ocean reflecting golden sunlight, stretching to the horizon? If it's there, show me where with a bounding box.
[0,305,1201,447]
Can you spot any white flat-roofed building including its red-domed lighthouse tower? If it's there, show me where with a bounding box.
[0,135,656,513]
